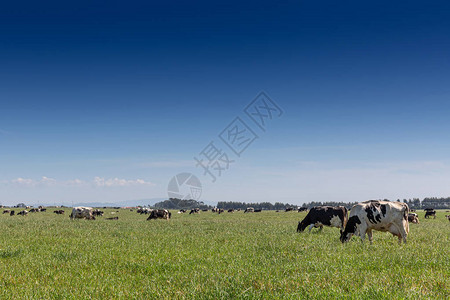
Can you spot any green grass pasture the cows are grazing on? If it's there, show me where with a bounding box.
[0,209,450,299]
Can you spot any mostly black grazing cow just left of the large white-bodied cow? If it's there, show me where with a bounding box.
[297,206,348,233]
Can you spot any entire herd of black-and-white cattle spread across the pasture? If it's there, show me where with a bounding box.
[3,200,450,243]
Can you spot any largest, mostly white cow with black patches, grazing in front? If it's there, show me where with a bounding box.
[340,200,409,243]
